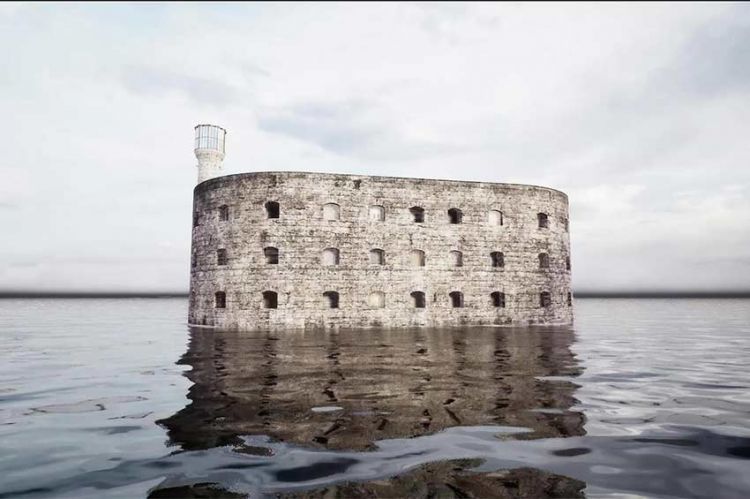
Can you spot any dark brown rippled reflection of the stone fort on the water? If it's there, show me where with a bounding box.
[160,327,585,497]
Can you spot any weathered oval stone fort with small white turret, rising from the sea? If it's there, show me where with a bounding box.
[189,125,573,330]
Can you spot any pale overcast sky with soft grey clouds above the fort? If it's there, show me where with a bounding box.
[0,3,750,292]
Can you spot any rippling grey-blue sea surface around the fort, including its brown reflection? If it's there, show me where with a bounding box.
[0,299,750,498]
